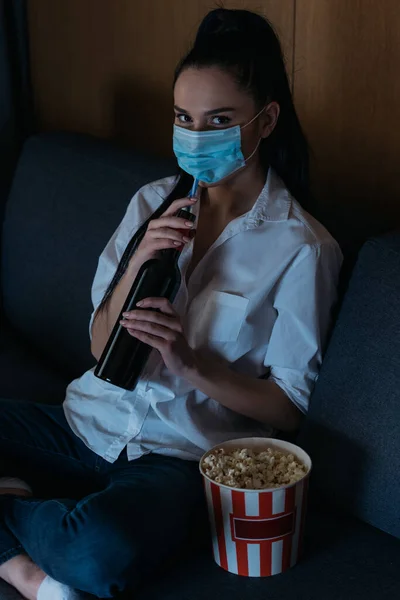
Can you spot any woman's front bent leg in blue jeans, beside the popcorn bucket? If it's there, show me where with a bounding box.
[3,455,203,598]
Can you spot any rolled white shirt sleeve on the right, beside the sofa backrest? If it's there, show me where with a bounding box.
[265,242,342,413]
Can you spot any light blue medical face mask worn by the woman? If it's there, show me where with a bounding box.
[173,108,265,184]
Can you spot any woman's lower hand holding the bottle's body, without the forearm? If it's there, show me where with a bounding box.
[120,298,196,377]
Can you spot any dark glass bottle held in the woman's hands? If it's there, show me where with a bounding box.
[94,209,195,390]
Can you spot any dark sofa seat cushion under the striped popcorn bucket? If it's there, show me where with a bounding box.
[136,513,400,600]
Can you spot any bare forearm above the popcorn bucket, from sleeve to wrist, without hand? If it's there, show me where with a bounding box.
[185,358,302,432]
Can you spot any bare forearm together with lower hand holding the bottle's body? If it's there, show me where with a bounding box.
[120,298,302,431]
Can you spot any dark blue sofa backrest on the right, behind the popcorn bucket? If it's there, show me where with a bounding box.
[299,232,400,537]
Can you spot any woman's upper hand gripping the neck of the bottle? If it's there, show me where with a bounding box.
[133,198,196,264]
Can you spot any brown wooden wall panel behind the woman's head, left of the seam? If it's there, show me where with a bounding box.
[28,0,294,154]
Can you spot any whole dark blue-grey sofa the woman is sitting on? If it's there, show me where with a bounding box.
[0,134,400,600]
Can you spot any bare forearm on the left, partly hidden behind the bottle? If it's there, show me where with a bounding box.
[91,259,140,360]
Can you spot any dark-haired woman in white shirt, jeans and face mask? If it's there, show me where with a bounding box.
[0,9,341,600]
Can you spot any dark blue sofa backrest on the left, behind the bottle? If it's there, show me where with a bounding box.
[2,134,176,377]
